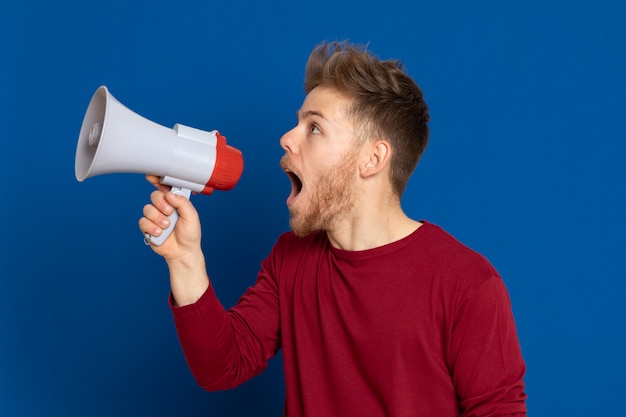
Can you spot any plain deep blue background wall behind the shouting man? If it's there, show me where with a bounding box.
[0,0,626,416]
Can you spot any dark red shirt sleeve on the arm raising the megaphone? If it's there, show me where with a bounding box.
[170,252,280,391]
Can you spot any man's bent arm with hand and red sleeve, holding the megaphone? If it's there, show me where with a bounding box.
[139,176,279,390]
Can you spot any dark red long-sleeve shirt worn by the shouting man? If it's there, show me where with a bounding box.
[172,222,526,417]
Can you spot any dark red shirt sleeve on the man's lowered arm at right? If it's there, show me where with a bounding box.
[451,276,526,417]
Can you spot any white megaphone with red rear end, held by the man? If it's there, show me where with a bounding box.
[75,86,243,246]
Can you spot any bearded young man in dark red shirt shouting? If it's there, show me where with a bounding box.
[139,43,526,417]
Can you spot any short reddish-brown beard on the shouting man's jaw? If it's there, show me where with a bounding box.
[289,148,358,237]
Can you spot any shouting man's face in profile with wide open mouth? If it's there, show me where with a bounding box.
[280,87,358,236]
